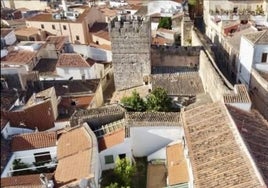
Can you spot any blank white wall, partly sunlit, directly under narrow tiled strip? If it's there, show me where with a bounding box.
[130,126,182,157]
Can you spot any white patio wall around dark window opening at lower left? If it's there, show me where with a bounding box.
[1,146,57,178]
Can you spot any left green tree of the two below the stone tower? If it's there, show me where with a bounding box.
[121,90,146,112]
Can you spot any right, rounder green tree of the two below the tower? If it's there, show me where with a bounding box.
[146,88,172,112]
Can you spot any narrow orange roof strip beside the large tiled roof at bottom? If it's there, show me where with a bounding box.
[166,143,189,185]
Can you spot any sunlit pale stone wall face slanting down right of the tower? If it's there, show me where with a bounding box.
[199,50,231,102]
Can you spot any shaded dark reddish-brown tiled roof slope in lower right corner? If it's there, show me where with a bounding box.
[227,105,268,185]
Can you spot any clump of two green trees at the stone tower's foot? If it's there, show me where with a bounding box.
[121,88,173,112]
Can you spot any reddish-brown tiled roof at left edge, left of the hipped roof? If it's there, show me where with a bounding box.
[1,50,37,64]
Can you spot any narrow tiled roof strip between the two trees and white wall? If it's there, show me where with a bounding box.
[126,112,180,126]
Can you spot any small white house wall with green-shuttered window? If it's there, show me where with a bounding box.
[99,138,132,170]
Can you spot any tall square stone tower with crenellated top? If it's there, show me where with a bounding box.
[109,15,151,90]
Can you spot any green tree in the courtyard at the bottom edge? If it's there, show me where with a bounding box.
[114,158,136,187]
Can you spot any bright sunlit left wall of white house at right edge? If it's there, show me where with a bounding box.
[237,37,254,86]
